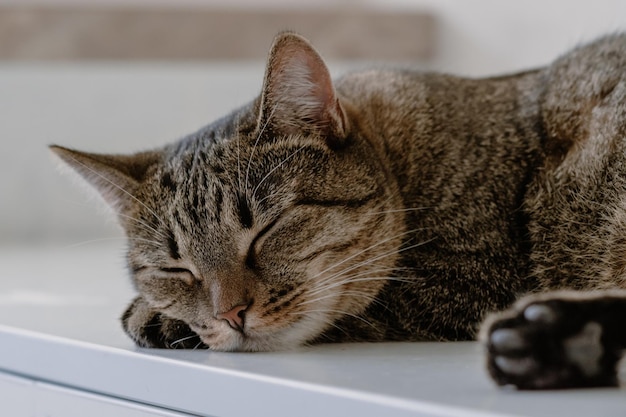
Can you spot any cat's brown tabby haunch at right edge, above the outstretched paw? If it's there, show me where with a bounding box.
[526,34,626,289]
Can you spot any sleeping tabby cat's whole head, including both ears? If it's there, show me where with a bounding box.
[52,33,404,350]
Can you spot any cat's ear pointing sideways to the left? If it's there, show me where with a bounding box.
[50,145,160,213]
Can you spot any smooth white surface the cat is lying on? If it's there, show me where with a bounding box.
[0,245,626,417]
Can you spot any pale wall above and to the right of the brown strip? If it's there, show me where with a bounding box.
[0,0,626,74]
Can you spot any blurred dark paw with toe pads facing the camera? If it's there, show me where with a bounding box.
[483,300,618,389]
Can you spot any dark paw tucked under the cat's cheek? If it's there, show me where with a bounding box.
[122,297,208,349]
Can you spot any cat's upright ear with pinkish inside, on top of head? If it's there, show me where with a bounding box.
[259,32,348,143]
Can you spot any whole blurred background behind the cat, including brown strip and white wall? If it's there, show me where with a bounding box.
[0,0,626,246]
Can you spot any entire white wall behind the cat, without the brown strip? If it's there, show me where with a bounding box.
[0,0,626,242]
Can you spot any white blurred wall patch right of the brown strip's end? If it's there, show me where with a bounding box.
[394,0,626,75]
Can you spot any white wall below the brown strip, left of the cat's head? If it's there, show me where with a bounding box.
[0,63,263,243]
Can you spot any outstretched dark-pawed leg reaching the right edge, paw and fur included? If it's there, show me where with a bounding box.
[481,291,626,389]
